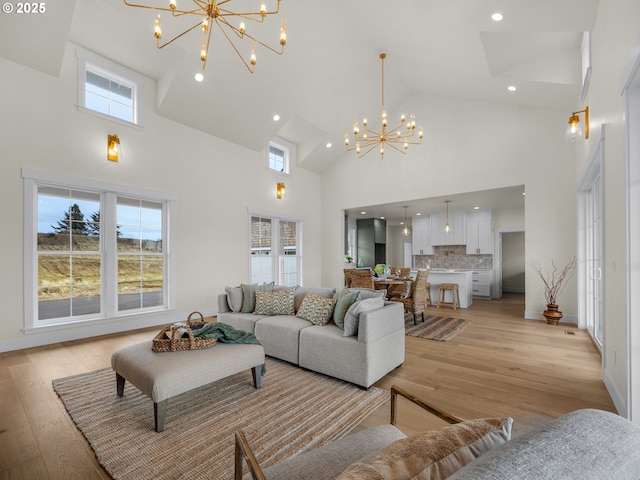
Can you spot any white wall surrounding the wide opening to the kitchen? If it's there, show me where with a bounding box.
[322,96,577,318]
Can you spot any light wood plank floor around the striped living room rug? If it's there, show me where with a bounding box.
[0,295,615,480]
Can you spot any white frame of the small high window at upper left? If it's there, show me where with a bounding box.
[76,49,144,128]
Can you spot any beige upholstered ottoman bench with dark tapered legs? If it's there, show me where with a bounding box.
[111,342,264,432]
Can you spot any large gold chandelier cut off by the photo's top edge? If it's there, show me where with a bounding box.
[124,0,287,73]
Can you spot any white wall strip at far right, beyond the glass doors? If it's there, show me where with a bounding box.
[576,0,640,414]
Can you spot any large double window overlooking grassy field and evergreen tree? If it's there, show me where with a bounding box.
[23,171,174,331]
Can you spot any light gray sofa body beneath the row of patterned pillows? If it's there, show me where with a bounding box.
[217,286,405,388]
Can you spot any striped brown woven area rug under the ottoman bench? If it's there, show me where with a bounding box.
[53,358,389,480]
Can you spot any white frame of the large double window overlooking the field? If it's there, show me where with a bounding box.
[22,169,175,333]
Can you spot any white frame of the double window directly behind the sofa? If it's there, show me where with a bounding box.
[247,209,304,286]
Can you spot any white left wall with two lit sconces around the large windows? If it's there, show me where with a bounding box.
[0,44,322,351]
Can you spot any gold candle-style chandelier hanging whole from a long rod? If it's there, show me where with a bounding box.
[344,52,423,158]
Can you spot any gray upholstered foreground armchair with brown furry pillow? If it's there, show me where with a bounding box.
[235,409,640,480]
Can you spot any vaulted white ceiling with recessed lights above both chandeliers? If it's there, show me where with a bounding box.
[0,0,598,172]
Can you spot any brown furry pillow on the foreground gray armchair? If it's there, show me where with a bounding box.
[338,417,518,480]
